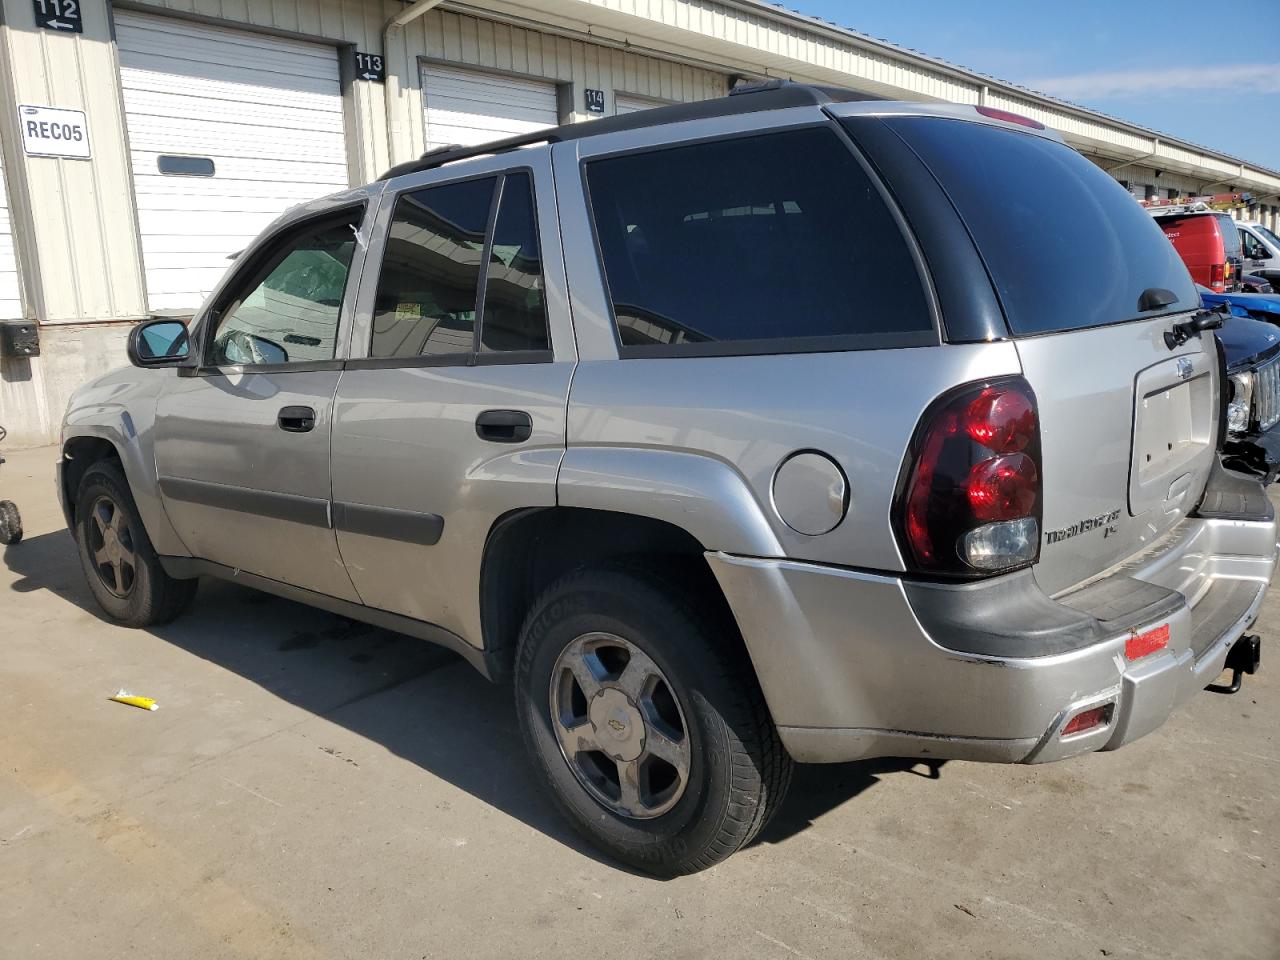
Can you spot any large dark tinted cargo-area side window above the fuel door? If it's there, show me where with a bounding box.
[588,129,932,352]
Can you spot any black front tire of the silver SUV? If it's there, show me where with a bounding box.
[76,460,198,627]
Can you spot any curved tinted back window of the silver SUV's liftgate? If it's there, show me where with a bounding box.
[887,116,1199,335]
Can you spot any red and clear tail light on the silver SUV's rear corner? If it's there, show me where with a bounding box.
[895,378,1042,577]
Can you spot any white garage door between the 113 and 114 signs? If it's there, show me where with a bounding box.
[421,64,559,150]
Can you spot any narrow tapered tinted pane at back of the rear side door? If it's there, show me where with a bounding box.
[480,173,548,351]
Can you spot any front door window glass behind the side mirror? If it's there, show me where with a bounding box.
[211,212,360,366]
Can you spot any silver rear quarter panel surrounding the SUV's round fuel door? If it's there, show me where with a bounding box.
[559,343,1020,571]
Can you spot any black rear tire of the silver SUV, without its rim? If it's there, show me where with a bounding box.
[515,563,792,877]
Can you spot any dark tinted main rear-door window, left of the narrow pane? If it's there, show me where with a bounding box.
[370,177,497,357]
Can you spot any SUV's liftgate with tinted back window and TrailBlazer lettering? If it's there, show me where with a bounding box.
[865,110,1219,593]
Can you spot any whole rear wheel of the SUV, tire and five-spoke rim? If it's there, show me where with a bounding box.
[516,563,791,877]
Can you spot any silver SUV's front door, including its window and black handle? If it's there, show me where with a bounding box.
[155,202,365,600]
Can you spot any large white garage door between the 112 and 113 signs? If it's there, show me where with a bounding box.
[115,10,349,310]
